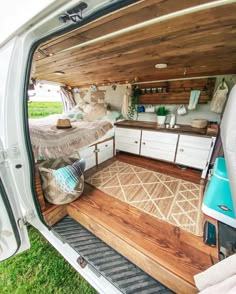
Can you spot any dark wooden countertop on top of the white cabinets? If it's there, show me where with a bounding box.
[115,120,208,136]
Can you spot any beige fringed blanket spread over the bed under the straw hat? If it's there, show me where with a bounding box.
[29,116,113,159]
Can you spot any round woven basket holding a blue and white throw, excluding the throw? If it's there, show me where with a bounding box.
[38,158,84,205]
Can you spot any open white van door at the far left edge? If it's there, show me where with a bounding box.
[0,38,29,261]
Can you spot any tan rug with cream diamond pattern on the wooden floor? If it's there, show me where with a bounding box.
[86,161,203,236]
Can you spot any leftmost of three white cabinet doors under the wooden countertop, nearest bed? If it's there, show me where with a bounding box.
[115,127,141,154]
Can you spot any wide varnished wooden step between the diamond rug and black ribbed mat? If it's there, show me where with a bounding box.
[67,184,217,293]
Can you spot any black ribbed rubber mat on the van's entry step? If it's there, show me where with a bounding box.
[53,216,173,294]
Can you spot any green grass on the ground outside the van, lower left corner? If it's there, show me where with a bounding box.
[0,227,96,294]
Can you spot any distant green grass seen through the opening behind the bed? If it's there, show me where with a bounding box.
[28,101,63,118]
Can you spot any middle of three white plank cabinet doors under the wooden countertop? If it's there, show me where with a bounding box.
[140,130,178,161]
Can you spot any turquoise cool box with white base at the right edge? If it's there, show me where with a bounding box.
[202,157,236,226]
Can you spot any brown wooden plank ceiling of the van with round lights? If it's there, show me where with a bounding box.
[32,0,236,87]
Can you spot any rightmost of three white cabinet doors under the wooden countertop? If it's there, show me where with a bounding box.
[175,135,212,169]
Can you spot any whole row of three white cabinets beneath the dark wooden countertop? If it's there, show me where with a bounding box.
[115,127,216,178]
